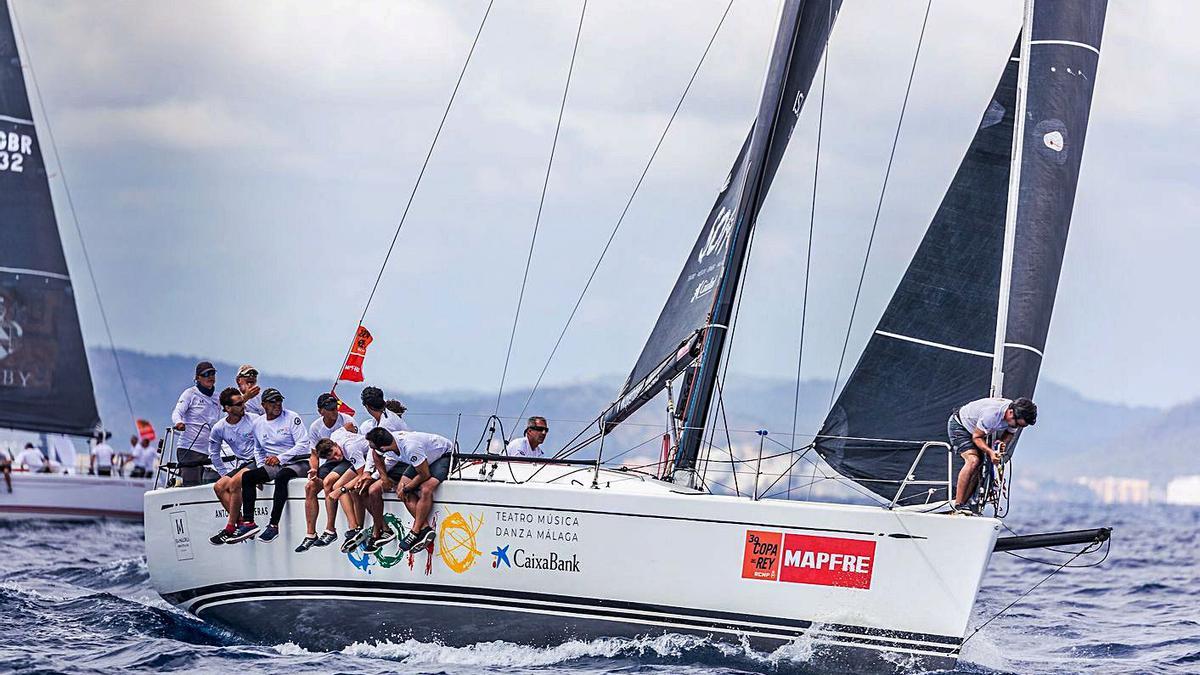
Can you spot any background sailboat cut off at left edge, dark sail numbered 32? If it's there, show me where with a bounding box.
[0,1,150,520]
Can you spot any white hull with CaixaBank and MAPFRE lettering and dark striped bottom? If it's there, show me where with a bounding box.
[145,467,998,664]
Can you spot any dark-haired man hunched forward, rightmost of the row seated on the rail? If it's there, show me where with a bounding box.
[367,429,454,551]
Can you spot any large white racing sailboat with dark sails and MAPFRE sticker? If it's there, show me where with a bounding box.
[145,0,1105,667]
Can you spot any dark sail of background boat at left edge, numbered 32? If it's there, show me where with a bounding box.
[0,1,100,436]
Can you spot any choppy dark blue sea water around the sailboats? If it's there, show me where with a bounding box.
[0,503,1200,675]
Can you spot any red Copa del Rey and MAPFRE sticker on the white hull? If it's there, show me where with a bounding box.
[742,530,875,589]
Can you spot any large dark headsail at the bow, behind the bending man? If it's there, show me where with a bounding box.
[816,0,1106,501]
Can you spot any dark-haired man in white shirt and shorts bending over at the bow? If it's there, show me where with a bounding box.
[946,398,1038,514]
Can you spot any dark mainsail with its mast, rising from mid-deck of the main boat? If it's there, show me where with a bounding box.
[605,0,841,478]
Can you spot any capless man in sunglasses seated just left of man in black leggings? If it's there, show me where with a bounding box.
[208,387,258,544]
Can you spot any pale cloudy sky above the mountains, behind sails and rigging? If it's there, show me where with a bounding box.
[12,0,1200,406]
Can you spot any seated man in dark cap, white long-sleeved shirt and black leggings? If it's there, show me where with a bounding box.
[227,388,311,544]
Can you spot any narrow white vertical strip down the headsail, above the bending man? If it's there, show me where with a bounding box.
[989,0,1033,396]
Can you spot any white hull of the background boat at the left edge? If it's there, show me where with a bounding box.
[0,471,147,520]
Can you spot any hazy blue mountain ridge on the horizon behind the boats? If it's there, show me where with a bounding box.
[90,350,1171,480]
